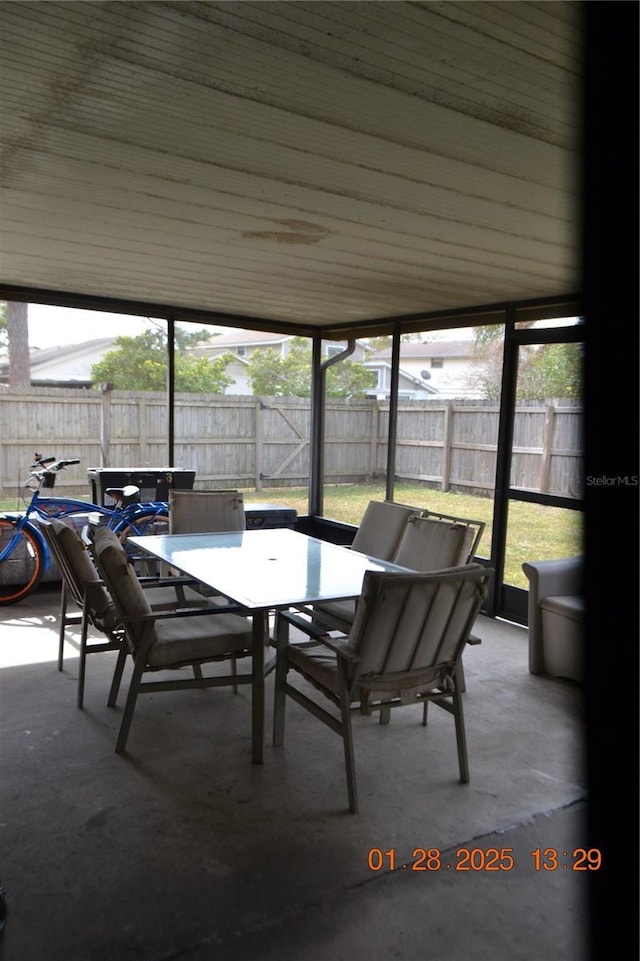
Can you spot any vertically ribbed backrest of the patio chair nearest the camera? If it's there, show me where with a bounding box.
[347,564,493,688]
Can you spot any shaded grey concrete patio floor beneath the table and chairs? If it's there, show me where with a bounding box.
[0,587,588,961]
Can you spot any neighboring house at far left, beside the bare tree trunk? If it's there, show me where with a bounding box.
[0,337,116,387]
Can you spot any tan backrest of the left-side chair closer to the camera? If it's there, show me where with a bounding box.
[94,527,155,654]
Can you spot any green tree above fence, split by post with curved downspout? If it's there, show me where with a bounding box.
[248,337,376,397]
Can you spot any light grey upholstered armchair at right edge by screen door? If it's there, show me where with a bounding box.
[522,557,584,681]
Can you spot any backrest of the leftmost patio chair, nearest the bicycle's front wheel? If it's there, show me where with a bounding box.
[40,517,115,626]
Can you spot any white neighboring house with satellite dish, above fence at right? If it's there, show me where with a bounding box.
[367,340,483,400]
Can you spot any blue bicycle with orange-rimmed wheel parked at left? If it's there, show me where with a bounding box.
[0,454,169,604]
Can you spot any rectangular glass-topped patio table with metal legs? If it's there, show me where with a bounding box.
[129,528,406,764]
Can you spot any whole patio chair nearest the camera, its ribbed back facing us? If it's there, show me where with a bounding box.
[273,564,492,814]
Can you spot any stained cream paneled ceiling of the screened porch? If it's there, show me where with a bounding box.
[0,0,584,333]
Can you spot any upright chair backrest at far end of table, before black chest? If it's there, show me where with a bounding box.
[169,490,246,534]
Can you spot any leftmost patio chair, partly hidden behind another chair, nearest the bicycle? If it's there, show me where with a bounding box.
[39,517,212,708]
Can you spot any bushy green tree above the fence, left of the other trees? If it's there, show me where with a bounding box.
[91,328,233,394]
